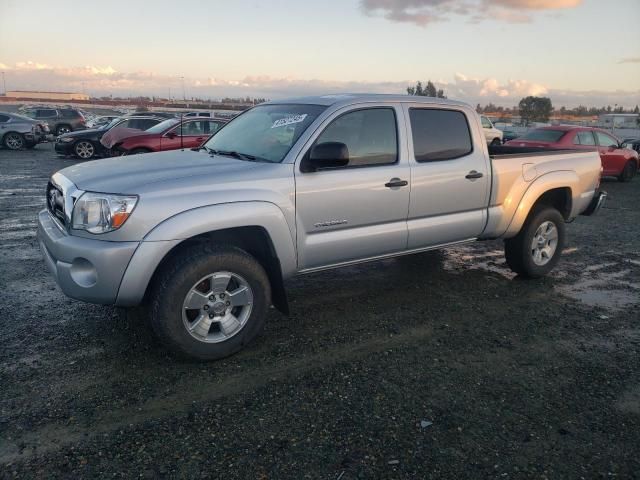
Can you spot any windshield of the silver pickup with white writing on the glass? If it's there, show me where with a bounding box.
[204,105,326,163]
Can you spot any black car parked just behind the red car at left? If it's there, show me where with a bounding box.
[55,114,165,160]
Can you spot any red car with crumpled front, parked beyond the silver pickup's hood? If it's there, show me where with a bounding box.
[101,118,227,155]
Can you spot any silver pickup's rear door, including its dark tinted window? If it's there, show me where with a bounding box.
[405,104,490,250]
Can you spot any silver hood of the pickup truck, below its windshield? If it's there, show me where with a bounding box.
[55,150,267,194]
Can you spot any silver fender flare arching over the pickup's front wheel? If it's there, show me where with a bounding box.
[116,201,297,307]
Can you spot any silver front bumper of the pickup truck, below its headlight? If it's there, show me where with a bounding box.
[38,210,139,305]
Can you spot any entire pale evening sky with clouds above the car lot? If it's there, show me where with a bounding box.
[0,0,640,107]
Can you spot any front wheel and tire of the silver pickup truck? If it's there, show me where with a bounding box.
[149,245,271,360]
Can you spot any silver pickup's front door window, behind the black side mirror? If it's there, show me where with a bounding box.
[315,108,398,167]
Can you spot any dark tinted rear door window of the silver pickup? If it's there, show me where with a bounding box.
[409,108,473,162]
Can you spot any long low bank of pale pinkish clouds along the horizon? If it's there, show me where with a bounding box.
[0,61,640,107]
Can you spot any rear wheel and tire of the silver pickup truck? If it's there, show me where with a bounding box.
[504,205,566,278]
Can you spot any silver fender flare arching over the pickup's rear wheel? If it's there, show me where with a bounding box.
[502,170,580,238]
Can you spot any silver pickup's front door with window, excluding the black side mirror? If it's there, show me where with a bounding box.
[295,105,410,270]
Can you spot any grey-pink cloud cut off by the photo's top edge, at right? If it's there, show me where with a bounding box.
[361,0,582,27]
